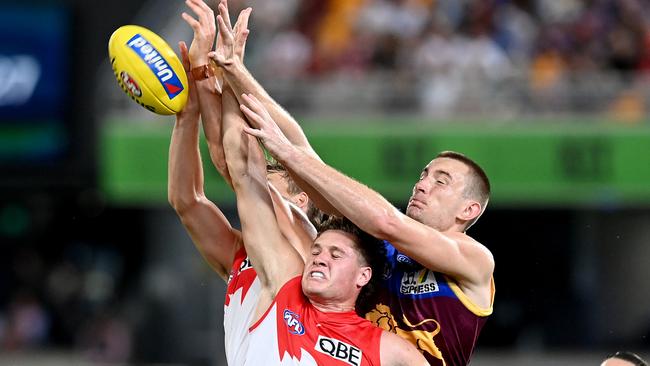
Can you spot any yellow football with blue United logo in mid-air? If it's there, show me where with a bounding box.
[108,25,188,115]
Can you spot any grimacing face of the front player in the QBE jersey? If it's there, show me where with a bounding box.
[302,230,372,305]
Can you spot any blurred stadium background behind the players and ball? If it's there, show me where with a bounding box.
[0,0,650,365]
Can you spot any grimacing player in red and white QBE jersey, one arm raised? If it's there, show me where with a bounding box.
[217,76,427,366]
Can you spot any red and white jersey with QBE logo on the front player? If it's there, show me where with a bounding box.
[246,276,382,366]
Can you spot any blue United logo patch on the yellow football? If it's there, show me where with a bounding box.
[126,34,183,99]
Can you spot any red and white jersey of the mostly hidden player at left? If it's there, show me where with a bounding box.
[223,247,261,366]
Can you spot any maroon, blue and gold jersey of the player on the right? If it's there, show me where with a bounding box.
[366,242,494,366]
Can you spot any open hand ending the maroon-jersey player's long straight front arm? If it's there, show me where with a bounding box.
[240,94,293,159]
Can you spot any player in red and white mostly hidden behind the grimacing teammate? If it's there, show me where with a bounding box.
[168,2,316,365]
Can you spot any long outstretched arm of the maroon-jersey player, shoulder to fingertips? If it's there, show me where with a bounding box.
[242,95,494,289]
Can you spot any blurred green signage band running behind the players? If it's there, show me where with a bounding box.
[100,120,650,207]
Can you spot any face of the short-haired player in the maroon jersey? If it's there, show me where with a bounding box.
[406,158,470,231]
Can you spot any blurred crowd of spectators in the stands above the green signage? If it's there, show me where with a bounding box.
[241,0,650,121]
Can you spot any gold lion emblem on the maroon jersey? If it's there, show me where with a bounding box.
[366,304,445,365]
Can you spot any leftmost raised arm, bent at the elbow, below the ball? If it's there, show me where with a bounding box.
[167,42,241,280]
